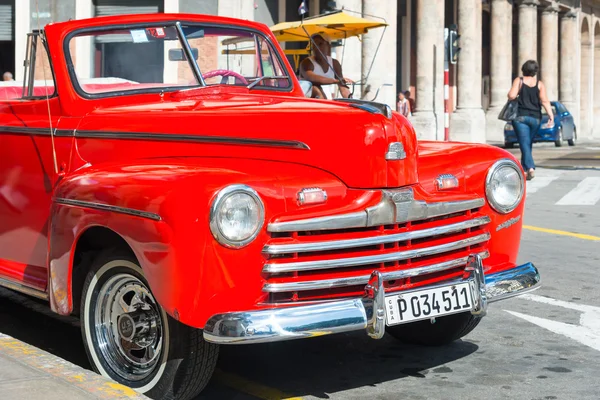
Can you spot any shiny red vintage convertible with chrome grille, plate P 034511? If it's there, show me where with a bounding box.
[0,14,540,399]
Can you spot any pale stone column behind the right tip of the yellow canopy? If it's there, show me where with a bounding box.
[355,0,398,110]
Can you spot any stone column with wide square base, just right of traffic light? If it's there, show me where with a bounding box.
[450,0,485,143]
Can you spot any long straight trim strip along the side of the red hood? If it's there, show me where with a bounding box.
[75,130,310,150]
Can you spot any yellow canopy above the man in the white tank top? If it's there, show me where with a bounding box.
[271,11,388,42]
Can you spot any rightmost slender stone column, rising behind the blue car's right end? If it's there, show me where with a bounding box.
[559,12,579,116]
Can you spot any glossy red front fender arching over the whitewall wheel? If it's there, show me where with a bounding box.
[49,158,346,327]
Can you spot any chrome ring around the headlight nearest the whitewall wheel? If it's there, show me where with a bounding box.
[210,184,265,249]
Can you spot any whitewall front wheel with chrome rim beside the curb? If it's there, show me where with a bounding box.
[81,251,219,399]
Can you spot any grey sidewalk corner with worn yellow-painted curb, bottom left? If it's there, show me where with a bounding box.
[0,333,148,400]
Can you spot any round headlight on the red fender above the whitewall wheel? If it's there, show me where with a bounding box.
[210,185,265,248]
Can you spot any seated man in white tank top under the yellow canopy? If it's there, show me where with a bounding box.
[300,33,352,99]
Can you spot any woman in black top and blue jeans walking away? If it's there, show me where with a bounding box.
[508,60,554,181]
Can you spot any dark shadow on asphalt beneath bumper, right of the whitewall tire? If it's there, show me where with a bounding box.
[214,332,479,399]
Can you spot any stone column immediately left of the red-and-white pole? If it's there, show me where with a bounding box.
[412,0,444,140]
